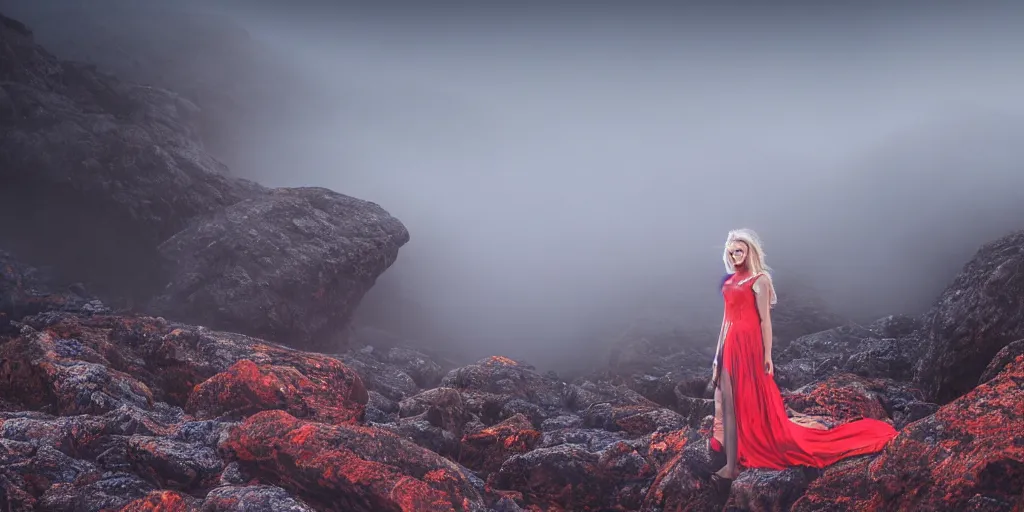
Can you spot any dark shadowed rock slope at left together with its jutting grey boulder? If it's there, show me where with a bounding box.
[0,12,409,349]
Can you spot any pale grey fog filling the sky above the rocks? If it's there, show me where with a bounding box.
[6,0,1024,367]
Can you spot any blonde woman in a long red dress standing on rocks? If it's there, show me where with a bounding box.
[712,229,896,485]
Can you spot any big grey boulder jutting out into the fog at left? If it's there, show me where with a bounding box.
[153,187,409,351]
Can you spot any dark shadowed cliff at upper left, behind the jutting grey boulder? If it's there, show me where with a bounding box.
[0,15,262,296]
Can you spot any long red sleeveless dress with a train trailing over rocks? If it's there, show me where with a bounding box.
[720,274,897,469]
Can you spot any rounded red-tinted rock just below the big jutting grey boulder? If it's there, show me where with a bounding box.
[185,355,369,423]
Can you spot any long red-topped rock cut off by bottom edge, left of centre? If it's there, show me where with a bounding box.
[221,411,484,512]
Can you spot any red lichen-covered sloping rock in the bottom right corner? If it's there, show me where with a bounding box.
[794,355,1024,511]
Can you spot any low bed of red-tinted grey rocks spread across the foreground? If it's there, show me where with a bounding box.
[0,237,1024,512]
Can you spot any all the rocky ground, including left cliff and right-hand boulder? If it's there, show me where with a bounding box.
[0,8,1024,512]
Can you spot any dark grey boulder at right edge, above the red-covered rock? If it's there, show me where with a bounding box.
[914,231,1024,403]
